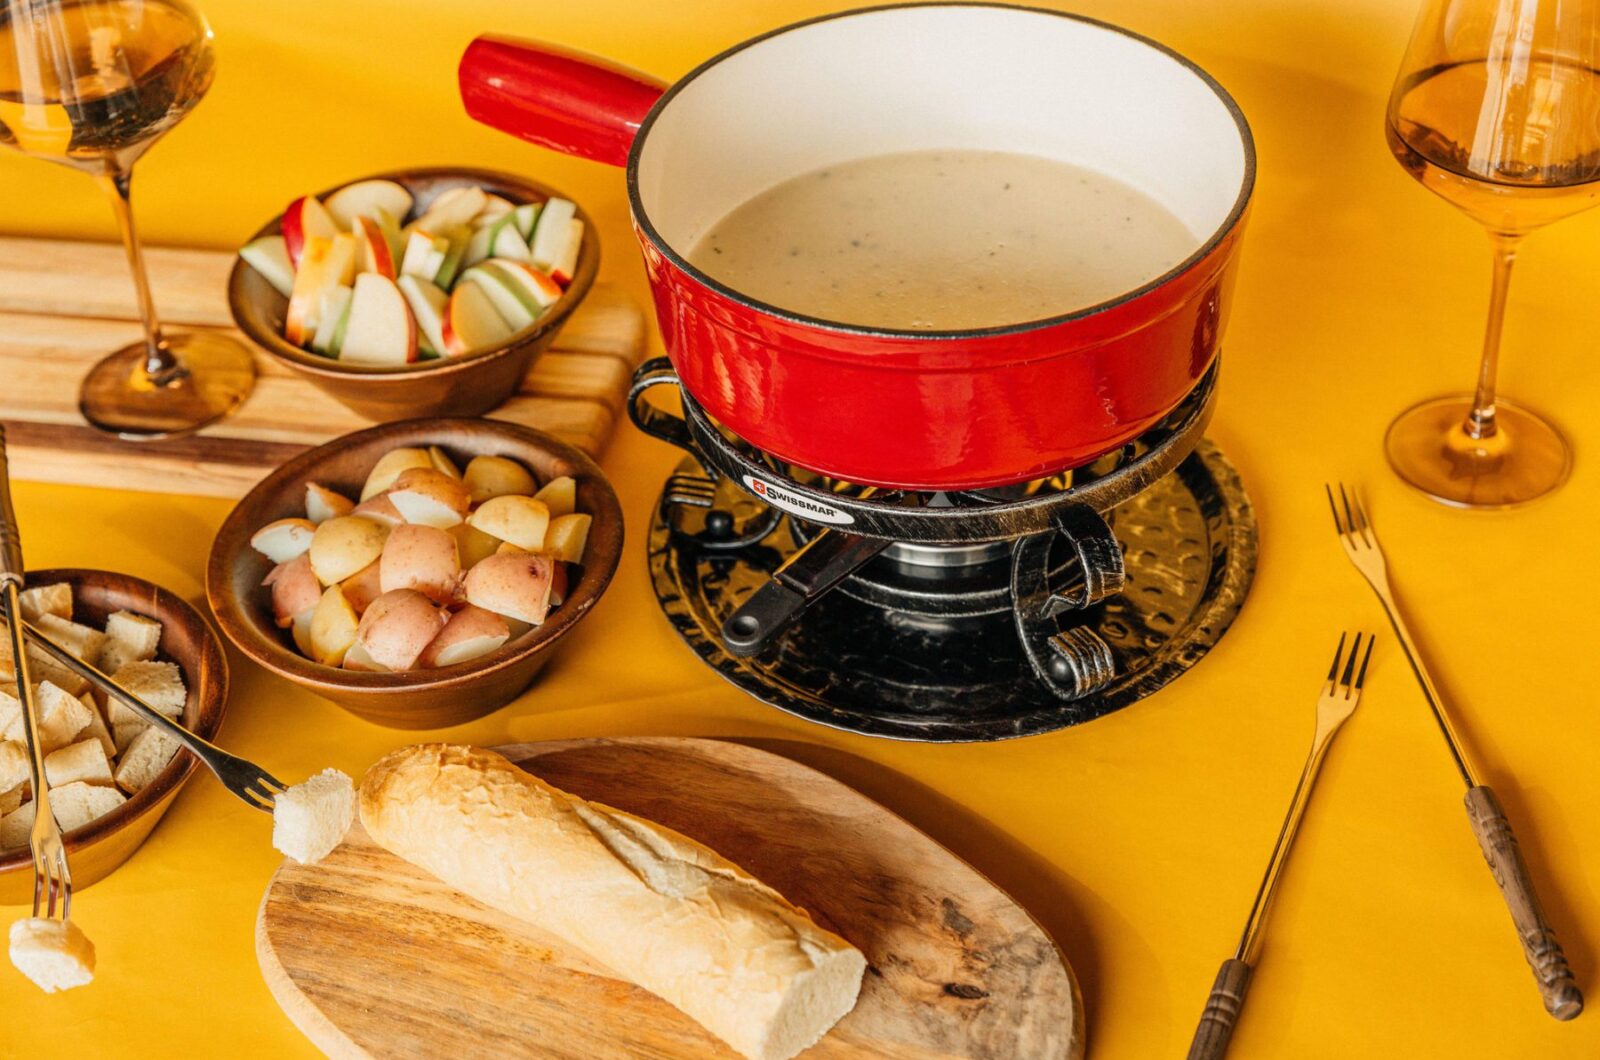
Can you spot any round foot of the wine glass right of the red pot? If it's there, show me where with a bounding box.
[1384,394,1573,508]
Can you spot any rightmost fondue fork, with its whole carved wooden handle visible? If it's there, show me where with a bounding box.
[1323,484,1584,1020]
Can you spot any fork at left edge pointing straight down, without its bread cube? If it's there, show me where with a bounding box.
[0,426,72,924]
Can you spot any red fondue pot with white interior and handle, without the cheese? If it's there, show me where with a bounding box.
[461,3,1256,490]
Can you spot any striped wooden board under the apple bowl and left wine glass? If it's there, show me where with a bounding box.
[0,239,645,496]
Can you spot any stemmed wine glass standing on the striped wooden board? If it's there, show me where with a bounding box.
[0,0,256,439]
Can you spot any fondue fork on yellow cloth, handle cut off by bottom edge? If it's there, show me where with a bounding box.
[1189,632,1374,1060]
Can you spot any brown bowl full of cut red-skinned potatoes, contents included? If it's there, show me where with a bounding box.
[206,420,622,729]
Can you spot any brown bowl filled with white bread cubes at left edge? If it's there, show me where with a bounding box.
[0,568,227,905]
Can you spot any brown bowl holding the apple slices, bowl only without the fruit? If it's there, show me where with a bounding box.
[227,168,600,423]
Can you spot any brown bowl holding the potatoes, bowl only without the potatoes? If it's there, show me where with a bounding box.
[206,420,622,729]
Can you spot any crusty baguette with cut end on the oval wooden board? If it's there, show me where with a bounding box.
[360,745,867,1060]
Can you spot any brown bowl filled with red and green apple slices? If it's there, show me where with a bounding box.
[227,168,600,423]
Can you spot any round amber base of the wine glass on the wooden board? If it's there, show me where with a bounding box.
[78,331,256,442]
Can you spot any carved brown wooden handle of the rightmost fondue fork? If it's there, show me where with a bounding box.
[1466,785,1584,1020]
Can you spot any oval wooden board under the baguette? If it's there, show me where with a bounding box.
[256,737,1083,1060]
